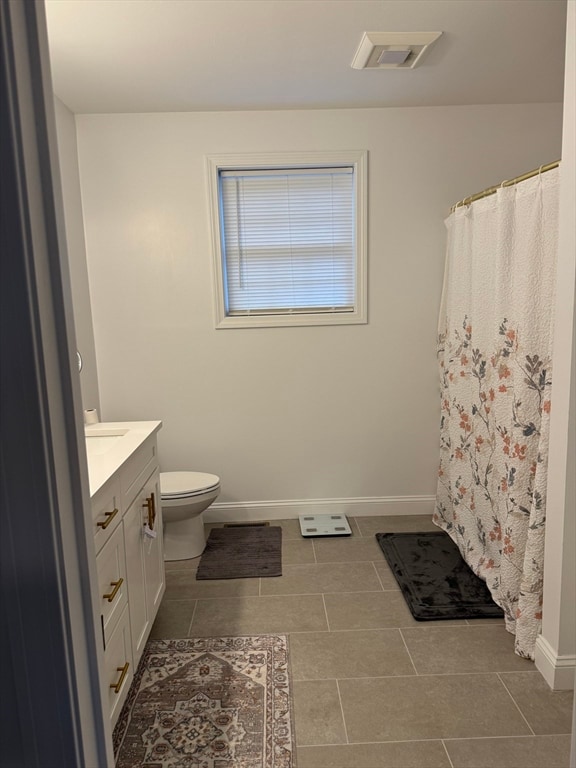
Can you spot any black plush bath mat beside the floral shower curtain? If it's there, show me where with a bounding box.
[376,531,504,621]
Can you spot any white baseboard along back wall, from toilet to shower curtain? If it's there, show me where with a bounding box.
[204,496,435,523]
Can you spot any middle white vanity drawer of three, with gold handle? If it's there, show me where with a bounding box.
[96,525,128,647]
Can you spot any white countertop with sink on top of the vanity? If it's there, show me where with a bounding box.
[84,421,162,498]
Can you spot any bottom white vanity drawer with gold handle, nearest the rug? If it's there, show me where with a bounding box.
[102,606,134,728]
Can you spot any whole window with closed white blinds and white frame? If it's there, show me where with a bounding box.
[207,152,366,328]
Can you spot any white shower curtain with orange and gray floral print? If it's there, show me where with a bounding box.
[434,168,559,659]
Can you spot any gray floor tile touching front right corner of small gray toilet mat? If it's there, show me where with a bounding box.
[261,563,380,595]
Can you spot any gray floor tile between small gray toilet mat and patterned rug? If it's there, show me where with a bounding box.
[190,595,328,637]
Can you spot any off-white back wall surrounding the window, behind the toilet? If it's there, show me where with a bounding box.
[77,104,562,513]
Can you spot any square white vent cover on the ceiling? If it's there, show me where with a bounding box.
[352,32,442,69]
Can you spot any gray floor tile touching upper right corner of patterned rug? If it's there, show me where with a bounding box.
[290,629,416,680]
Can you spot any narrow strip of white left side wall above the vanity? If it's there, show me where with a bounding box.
[54,98,100,408]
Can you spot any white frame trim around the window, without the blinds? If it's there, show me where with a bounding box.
[206,150,368,329]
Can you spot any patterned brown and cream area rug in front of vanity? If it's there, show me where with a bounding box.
[114,635,294,768]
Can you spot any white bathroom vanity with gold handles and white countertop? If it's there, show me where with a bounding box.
[85,421,166,729]
